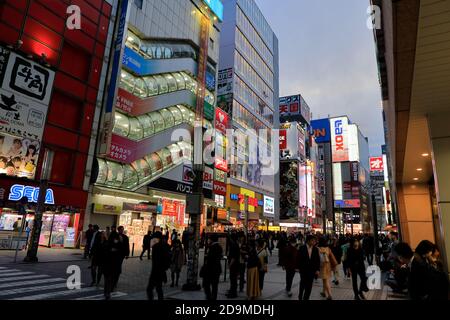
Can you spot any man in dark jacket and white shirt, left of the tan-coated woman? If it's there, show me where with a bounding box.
[297,235,320,300]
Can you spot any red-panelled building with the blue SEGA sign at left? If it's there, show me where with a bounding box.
[0,0,114,248]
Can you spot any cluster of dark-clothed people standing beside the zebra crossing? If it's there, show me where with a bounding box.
[85,224,130,300]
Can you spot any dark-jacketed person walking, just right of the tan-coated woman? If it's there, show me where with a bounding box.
[347,239,369,300]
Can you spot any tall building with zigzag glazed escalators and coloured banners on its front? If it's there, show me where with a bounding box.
[88,0,225,247]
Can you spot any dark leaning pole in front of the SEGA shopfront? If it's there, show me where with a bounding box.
[24,149,54,262]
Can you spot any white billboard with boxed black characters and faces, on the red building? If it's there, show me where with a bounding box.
[0,46,55,179]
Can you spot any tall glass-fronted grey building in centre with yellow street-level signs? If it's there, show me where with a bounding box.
[218,0,279,228]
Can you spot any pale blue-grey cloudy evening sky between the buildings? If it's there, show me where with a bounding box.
[256,0,384,155]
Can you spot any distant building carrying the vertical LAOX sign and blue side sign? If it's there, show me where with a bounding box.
[312,116,372,233]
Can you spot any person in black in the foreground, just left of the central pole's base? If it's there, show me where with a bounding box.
[147,231,170,300]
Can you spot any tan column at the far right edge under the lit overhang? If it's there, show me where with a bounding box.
[428,112,450,271]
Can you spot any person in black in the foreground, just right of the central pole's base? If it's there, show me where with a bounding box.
[203,234,223,301]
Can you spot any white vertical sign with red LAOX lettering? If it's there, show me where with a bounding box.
[330,117,349,162]
